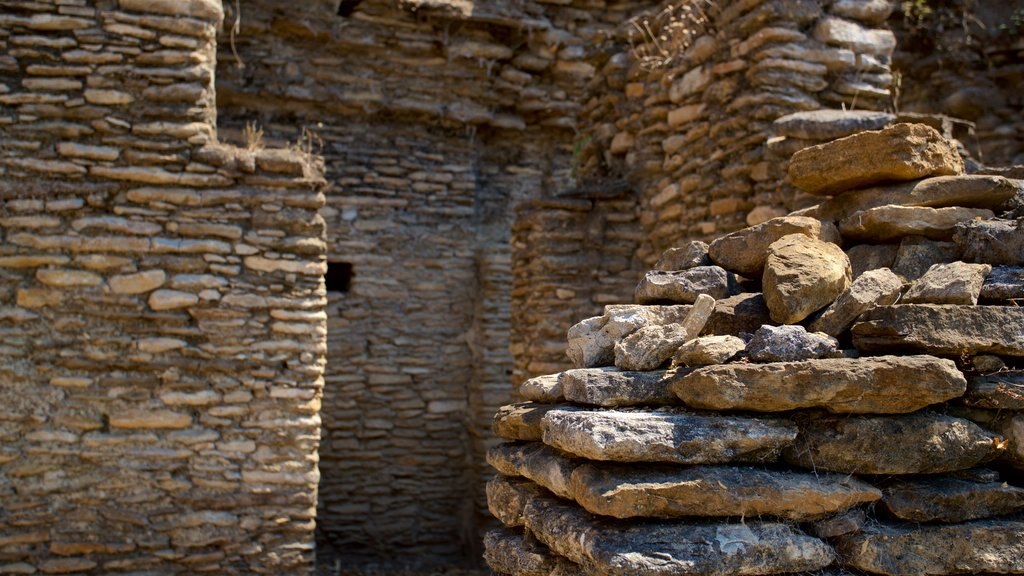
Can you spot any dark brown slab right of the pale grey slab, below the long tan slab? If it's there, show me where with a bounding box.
[783,413,996,475]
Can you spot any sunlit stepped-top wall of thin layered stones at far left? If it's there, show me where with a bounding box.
[0,0,326,574]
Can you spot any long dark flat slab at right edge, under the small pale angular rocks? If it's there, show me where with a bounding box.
[852,304,1024,358]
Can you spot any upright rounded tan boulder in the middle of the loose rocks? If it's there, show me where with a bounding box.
[762,234,853,324]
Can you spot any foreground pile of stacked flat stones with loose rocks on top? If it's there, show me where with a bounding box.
[485,124,1024,576]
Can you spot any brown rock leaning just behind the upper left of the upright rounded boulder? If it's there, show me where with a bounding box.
[709,216,840,278]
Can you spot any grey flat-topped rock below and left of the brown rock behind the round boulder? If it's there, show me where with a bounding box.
[636,266,738,304]
